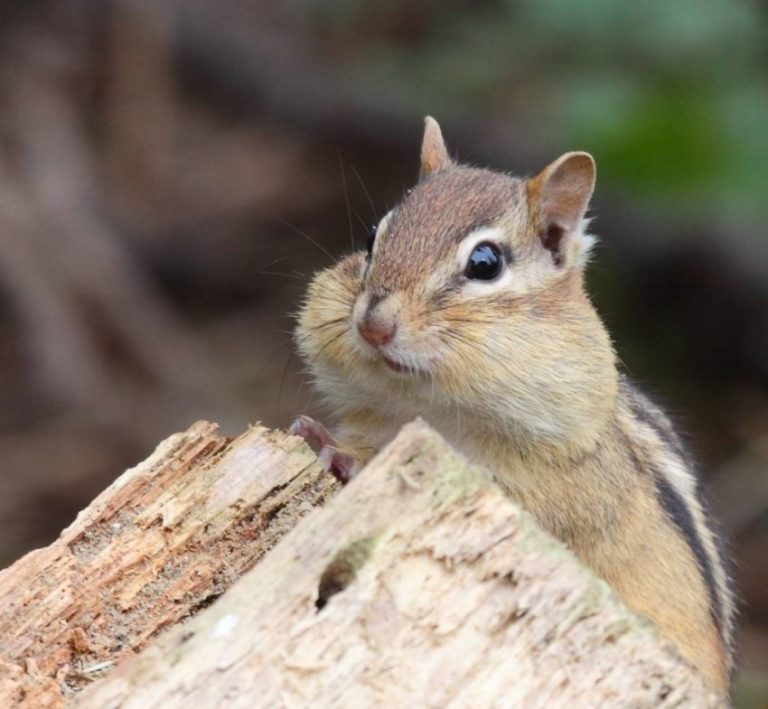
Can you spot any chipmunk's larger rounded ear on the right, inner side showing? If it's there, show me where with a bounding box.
[526,153,595,266]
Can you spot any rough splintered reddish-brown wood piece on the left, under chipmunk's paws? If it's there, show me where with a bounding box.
[0,422,338,708]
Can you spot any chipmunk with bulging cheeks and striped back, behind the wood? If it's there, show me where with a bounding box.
[291,117,734,695]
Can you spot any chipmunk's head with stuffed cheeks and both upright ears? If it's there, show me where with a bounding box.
[298,118,616,442]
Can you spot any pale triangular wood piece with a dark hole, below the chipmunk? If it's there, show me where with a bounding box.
[75,423,720,709]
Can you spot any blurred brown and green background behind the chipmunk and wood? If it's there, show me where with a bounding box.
[0,0,768,696]
